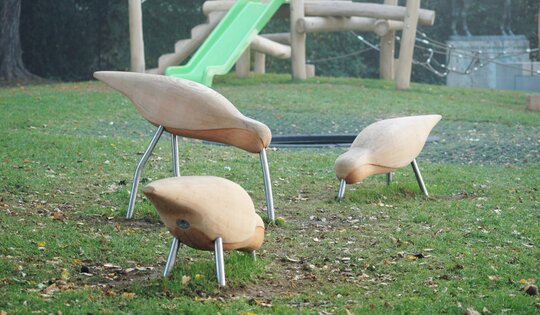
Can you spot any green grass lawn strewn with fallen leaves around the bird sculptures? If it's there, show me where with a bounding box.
[0,75,540,315]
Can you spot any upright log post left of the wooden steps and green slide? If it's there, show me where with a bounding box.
[128,0,145,72]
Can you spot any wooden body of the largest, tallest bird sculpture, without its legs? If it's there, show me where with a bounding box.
[94,71,272,153]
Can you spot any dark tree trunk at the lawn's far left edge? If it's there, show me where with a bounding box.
[0,0,40,82]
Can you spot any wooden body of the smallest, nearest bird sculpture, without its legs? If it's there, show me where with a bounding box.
[143,176,264,251]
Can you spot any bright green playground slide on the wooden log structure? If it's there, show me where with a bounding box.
[165,0,285,86]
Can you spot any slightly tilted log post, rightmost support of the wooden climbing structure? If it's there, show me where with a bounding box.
[396,0,420,90]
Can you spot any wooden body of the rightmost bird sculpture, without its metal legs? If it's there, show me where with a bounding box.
[335,115,441,184]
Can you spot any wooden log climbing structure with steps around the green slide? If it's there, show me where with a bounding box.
[129,0,435,90]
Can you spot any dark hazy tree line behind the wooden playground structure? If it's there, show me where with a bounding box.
[14,0,540,83]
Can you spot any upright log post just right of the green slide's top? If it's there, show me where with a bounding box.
[290,0,306,80]
